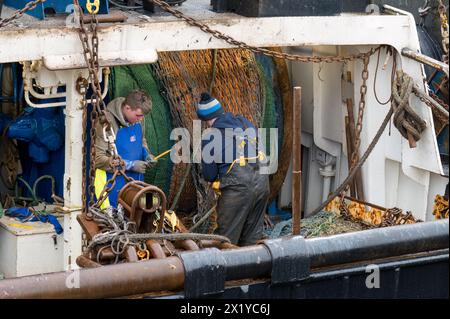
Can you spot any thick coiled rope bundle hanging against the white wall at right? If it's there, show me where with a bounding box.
[392,70,427,142]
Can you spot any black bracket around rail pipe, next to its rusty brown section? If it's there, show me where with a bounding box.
[178,248,226,298]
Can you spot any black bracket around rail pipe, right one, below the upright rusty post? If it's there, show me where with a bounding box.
[263,236,310,284]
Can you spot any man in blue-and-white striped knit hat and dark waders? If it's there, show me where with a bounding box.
[197,93,269,246]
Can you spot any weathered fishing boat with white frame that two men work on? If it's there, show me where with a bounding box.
[0,0,449,298]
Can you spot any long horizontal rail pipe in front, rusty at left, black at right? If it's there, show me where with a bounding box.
[0,219,449,299]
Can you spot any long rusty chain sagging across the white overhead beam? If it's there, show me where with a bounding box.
[151,0,380,63]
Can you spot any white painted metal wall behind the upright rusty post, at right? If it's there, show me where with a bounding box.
[279,46,445,220]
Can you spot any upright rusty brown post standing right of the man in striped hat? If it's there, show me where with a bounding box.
[292,87,302,235]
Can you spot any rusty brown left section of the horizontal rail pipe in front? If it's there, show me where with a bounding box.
[0,257,184,299]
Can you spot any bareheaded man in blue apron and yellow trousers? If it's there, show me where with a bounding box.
[95,90,156,209]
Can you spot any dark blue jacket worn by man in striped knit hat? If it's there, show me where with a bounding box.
[202,112,257,182]
